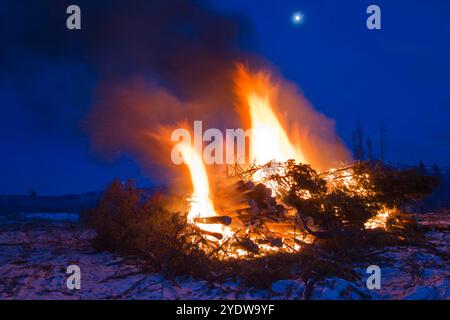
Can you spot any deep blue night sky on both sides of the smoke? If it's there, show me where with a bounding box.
[0,0,450,194]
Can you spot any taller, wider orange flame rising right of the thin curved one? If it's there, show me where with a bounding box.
[235,64,351,170]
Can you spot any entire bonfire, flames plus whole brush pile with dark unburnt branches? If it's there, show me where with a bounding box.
[88,65,437,287]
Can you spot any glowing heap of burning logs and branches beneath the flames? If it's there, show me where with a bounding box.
[185,161,433,256]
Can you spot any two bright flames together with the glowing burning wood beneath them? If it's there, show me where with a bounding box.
[163,66,436,259]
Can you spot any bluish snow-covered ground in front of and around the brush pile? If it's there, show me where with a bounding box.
[0,214,450,300]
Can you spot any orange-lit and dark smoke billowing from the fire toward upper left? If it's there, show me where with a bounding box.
[8,0,349,184]
